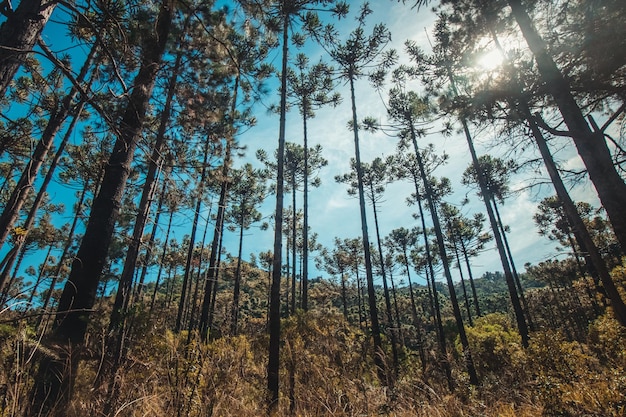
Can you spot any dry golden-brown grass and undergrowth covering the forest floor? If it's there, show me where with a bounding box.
[0,308,626,417]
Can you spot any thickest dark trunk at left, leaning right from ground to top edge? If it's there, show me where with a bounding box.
[26,0,174,416]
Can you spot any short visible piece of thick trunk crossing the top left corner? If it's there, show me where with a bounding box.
[0,0,58,99]
